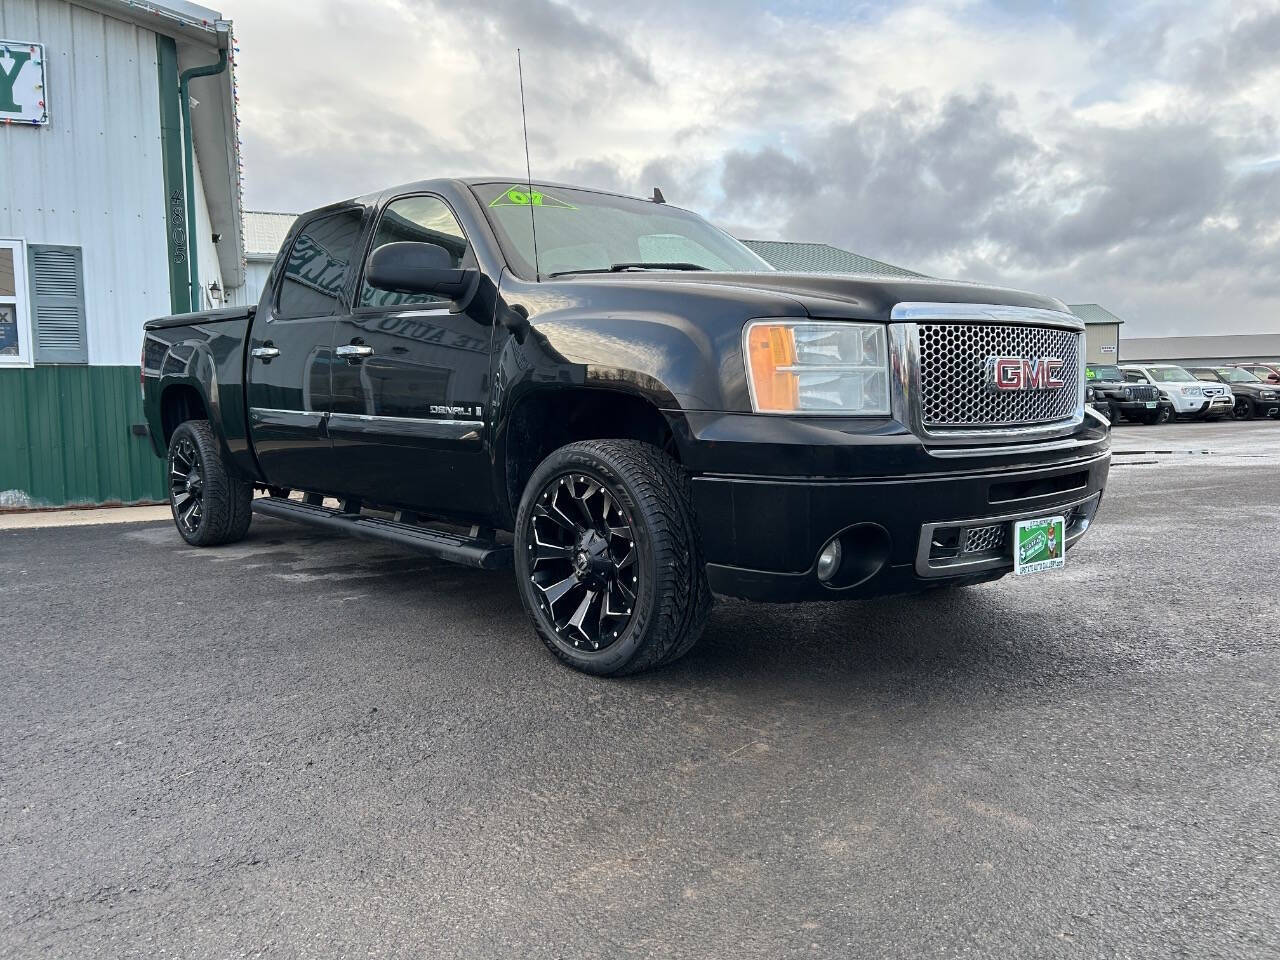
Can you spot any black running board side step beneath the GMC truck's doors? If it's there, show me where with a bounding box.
[253,497,513,570]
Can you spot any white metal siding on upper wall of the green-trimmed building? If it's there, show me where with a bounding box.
[0,0,168,365]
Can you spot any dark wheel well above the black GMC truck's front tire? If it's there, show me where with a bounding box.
[506,388,680,518]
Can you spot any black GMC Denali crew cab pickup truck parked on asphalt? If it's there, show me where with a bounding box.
[142,179,1110,675]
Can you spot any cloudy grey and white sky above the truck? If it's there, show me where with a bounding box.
[230,0,1280,337]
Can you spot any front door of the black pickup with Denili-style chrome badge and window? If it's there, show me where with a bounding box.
[329,195,493,522]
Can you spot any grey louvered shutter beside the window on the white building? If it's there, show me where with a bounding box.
[27,243,88,364]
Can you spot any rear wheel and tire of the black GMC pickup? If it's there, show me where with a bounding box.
[166,420,253,547]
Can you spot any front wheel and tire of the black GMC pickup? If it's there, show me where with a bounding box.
[516,440,712,676]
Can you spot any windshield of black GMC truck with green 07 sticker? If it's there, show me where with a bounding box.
[472,180,773,278]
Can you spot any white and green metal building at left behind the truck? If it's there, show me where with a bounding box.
[0,0,244,508]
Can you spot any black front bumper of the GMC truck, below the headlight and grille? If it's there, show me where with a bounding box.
[692,448,1111,602]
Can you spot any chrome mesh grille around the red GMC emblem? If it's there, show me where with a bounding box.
[918,323,1084,428]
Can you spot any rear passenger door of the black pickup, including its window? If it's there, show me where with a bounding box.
[246,206,365,493]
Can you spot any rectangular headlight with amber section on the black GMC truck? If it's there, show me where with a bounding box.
[742,320,890,416]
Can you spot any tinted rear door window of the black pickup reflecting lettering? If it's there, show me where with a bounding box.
[275,209,361,320]
